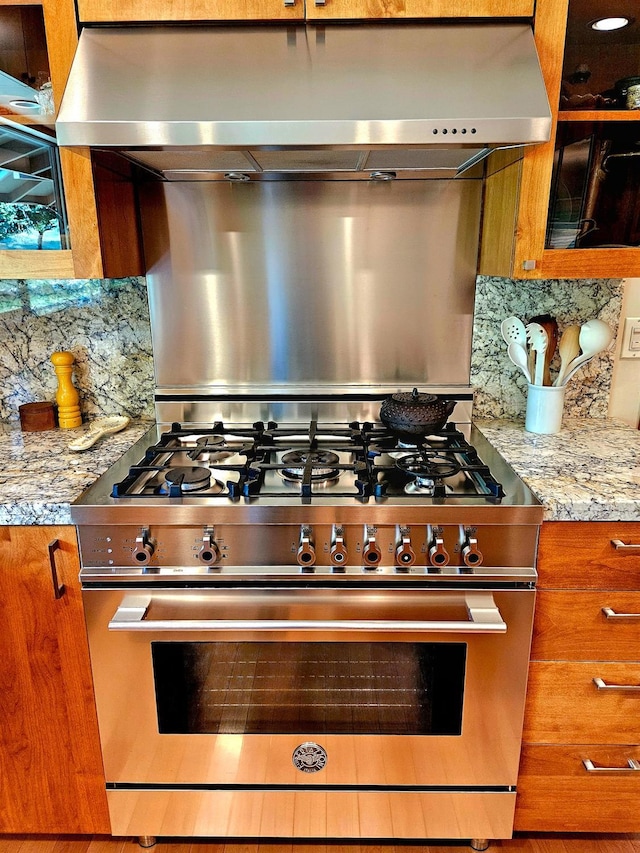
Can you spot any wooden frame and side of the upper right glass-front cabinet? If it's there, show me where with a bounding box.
[479,0,640,279]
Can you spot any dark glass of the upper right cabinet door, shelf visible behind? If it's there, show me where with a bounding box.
[546,0,640,249]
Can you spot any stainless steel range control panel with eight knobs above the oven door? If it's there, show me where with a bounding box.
[79,524,538,574]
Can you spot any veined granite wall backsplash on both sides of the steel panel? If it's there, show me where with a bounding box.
[0,276,622,421]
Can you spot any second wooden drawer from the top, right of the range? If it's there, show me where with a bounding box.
[531,589,640,661]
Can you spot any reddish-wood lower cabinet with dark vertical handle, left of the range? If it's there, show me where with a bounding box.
[0,527,110,834]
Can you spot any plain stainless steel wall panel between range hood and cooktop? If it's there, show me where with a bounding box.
[141,180,482,396]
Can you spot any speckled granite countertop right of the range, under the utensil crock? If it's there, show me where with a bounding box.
[475,417,640,522]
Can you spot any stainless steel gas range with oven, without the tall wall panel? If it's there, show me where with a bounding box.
[74,404,541,848]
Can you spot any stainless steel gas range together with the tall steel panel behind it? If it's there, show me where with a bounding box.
[72,166,542,849]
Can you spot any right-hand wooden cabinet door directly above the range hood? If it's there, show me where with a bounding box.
[306,0,534,19]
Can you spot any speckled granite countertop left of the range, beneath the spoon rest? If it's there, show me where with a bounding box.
[0,420,152,524]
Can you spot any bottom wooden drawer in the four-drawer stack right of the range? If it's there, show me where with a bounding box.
[515,744,640,832]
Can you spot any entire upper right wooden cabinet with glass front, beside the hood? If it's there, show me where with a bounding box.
[479,0,640,279]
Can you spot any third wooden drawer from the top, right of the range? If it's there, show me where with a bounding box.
[523,661,640,744]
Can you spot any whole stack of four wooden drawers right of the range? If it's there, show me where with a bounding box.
[515,522,640,832]
